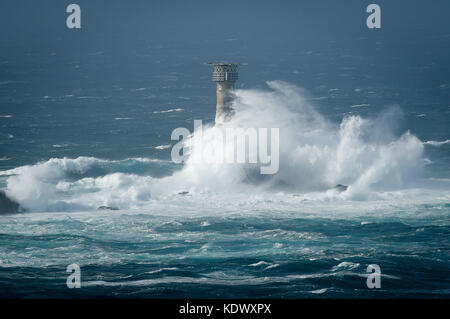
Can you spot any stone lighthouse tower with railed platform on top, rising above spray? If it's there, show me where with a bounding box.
[208,62,245,124]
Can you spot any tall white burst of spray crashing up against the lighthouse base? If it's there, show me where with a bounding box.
[174,82,423,198]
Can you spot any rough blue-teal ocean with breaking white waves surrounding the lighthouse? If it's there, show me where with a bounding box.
[0,0,450,298]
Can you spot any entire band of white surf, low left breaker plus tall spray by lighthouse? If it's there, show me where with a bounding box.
[0,82,445,216]
